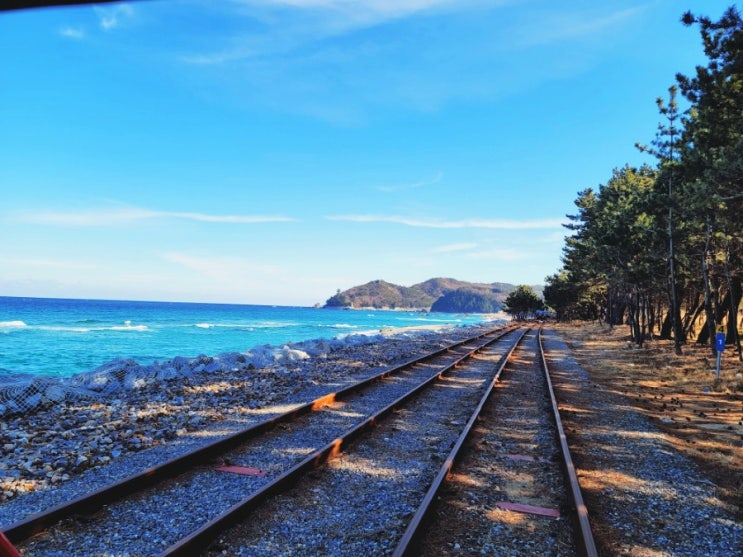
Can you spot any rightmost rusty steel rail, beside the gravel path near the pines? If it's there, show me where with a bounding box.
[537,327,599,557]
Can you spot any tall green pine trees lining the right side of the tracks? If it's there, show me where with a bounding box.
[544,6,743,360]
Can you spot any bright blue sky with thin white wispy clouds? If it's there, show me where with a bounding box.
[0,0,731,305]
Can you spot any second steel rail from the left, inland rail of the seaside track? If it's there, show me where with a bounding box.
[160,327,523,557]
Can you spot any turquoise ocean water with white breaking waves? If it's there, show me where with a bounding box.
[0,297,494,377]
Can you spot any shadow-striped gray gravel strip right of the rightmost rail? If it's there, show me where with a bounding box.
[545,331,743,557]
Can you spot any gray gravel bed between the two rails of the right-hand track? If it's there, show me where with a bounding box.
[422,331,576,557]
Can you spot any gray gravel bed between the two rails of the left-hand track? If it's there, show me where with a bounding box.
[7,324,512,555]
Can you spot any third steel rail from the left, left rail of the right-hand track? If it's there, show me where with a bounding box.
[392,328,530,557]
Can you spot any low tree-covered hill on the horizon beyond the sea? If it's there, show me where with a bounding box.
[324,278,541,313]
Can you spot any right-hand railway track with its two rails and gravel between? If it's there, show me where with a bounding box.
[394,329,598,557]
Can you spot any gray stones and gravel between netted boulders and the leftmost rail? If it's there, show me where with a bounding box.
[0,327,494,526]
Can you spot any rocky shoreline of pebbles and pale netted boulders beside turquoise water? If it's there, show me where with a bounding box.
[0,326,494,512]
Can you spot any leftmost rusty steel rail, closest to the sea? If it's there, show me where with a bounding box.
[0,327,513,544]
